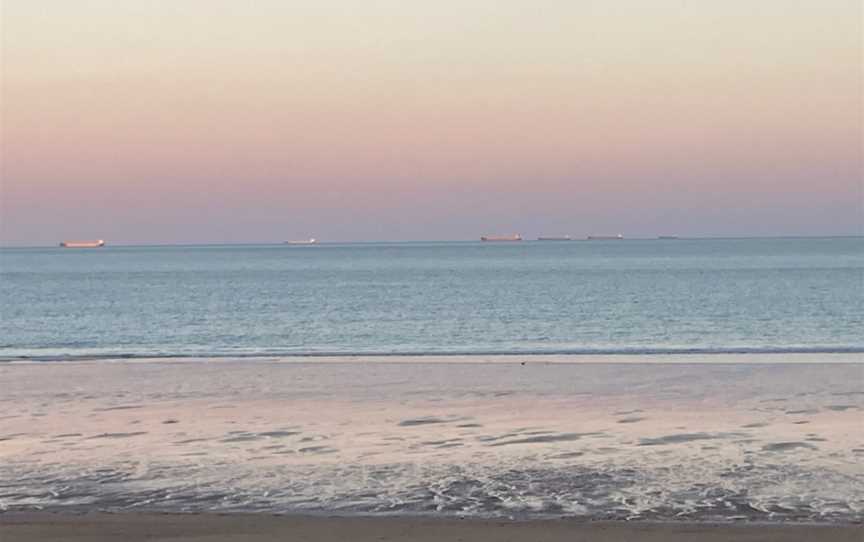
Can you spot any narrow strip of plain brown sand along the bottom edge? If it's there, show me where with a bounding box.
[0,513,864,542]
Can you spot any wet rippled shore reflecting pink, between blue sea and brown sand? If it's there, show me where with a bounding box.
[0,356,864,521]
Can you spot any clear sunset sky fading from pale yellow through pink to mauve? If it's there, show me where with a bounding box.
[0,0,864,245]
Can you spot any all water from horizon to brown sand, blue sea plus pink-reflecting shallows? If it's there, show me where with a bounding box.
[0,238,864,523]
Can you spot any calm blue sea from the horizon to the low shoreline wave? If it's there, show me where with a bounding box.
[0,238,864,359]
